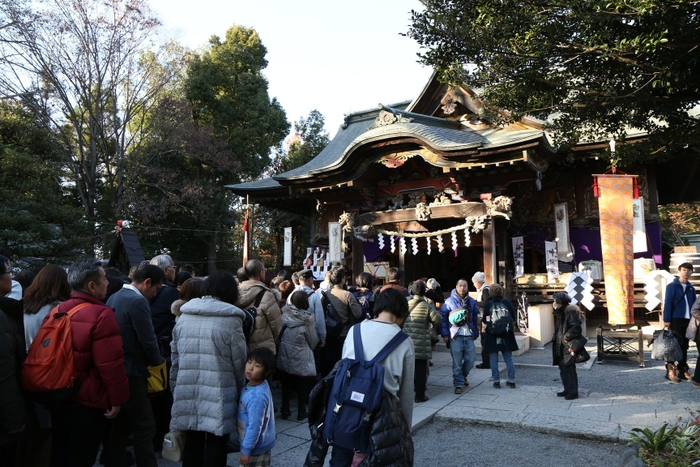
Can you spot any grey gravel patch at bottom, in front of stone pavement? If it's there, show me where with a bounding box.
[413,420,622,467]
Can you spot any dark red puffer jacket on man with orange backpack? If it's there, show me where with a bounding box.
[58,292,129,409]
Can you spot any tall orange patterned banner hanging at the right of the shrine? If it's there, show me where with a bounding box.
[597,175,635,324]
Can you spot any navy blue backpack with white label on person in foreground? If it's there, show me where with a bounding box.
[323,324,408,453]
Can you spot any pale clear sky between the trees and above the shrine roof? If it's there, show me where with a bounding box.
[150,0,432,138]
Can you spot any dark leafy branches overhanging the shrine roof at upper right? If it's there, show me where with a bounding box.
[408,0,700,162]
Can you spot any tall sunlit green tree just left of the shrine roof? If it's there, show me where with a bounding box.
[184,26,289,184]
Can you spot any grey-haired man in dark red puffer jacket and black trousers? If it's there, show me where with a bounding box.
[51,259,130,467]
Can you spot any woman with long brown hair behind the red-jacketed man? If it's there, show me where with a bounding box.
[23,265,71,350]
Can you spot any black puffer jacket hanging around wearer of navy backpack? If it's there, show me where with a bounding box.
[304,367,413,467]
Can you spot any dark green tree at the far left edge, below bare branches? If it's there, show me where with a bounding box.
[0,102,90,264]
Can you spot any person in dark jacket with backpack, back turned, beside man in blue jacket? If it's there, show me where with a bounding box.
[483,284,518,388]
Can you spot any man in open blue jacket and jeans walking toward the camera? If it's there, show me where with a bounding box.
[440,279,479,394]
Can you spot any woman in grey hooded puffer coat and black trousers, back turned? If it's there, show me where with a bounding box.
[277,290,318,421]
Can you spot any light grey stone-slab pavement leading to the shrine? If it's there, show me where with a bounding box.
[150,337,700,467]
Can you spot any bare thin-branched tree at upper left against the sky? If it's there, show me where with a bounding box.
[0,0,167,251]
